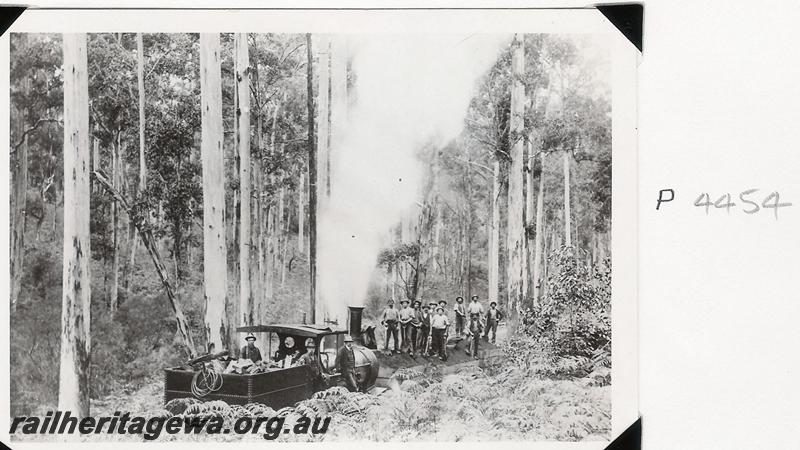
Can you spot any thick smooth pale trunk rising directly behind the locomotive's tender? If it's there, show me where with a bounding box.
[200,33,228,351]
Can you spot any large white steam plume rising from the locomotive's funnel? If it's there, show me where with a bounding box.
[317,35,510,324]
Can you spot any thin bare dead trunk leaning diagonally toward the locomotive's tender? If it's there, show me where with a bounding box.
[92,171,197,359]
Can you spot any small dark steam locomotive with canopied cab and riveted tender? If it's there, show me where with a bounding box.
[164,306,380,409]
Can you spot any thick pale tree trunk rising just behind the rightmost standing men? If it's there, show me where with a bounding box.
[507,34,526,332]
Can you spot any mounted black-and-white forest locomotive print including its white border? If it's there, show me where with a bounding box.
[0,9,638,442]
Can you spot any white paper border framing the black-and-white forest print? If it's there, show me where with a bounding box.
[0,1,640,450]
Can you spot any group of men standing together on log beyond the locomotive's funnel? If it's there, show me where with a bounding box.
[381,295,503,361]
